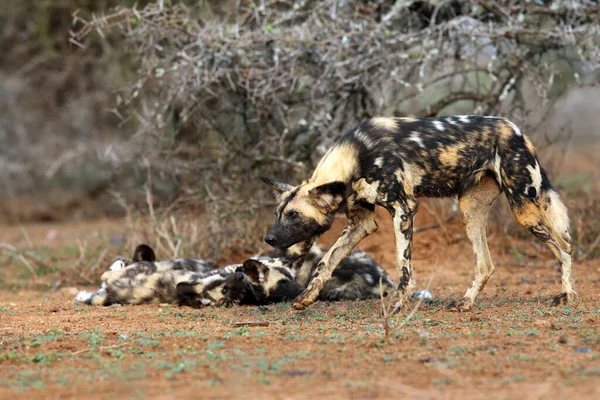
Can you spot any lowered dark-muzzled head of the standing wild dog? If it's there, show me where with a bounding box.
[261,177,346,249]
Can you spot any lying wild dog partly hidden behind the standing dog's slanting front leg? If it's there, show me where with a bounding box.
[164,241,393,306]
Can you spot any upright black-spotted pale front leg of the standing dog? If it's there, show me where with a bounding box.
[393,198,419,312]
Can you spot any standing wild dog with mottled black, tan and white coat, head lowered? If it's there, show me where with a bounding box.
[263,116,575,311]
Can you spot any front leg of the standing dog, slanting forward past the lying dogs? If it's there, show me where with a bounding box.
[292,203,377,310]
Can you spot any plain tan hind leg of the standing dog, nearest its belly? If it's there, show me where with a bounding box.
[447,176,501,311]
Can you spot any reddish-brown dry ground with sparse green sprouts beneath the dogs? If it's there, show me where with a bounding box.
[0,208,600,399]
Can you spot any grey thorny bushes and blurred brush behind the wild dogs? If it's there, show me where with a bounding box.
[0,0,600,264]
